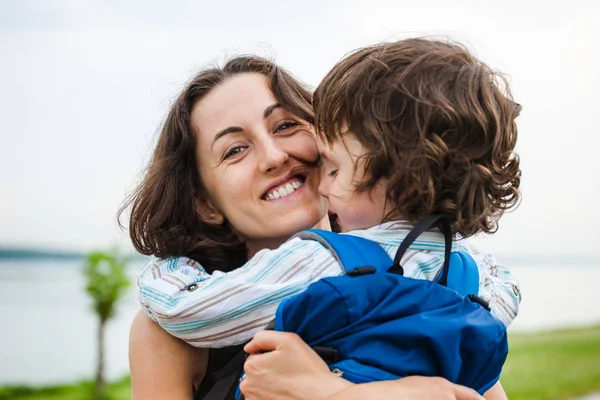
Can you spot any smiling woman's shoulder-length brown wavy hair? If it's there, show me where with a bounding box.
[118,56,314,271]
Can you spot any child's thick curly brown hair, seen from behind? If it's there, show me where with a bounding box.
[314,39,521,237]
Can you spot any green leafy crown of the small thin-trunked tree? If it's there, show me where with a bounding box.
[84,250,130,322]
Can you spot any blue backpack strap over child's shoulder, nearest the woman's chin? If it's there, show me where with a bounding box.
[294,229,392,272]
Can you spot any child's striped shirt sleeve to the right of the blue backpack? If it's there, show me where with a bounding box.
[466,243,521,327]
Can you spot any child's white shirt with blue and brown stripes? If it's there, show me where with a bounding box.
[138,221,521,348]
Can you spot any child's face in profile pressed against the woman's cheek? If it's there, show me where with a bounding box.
[317,133,387,232]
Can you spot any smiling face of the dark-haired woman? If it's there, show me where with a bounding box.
[191,73,327,252]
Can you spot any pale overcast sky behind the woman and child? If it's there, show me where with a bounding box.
[0,0,600,259]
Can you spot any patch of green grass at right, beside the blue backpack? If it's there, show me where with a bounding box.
[501,326,600,400]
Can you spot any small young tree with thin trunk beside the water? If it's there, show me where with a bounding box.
[83,250,129,398]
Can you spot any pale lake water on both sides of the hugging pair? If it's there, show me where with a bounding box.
[0,261,600,385]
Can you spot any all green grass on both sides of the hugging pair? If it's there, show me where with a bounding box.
[0,325,600,400]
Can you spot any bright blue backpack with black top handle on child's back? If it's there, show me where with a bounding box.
[200,215,508,400]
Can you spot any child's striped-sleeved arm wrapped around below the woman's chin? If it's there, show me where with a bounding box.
[138,239,342,347]
